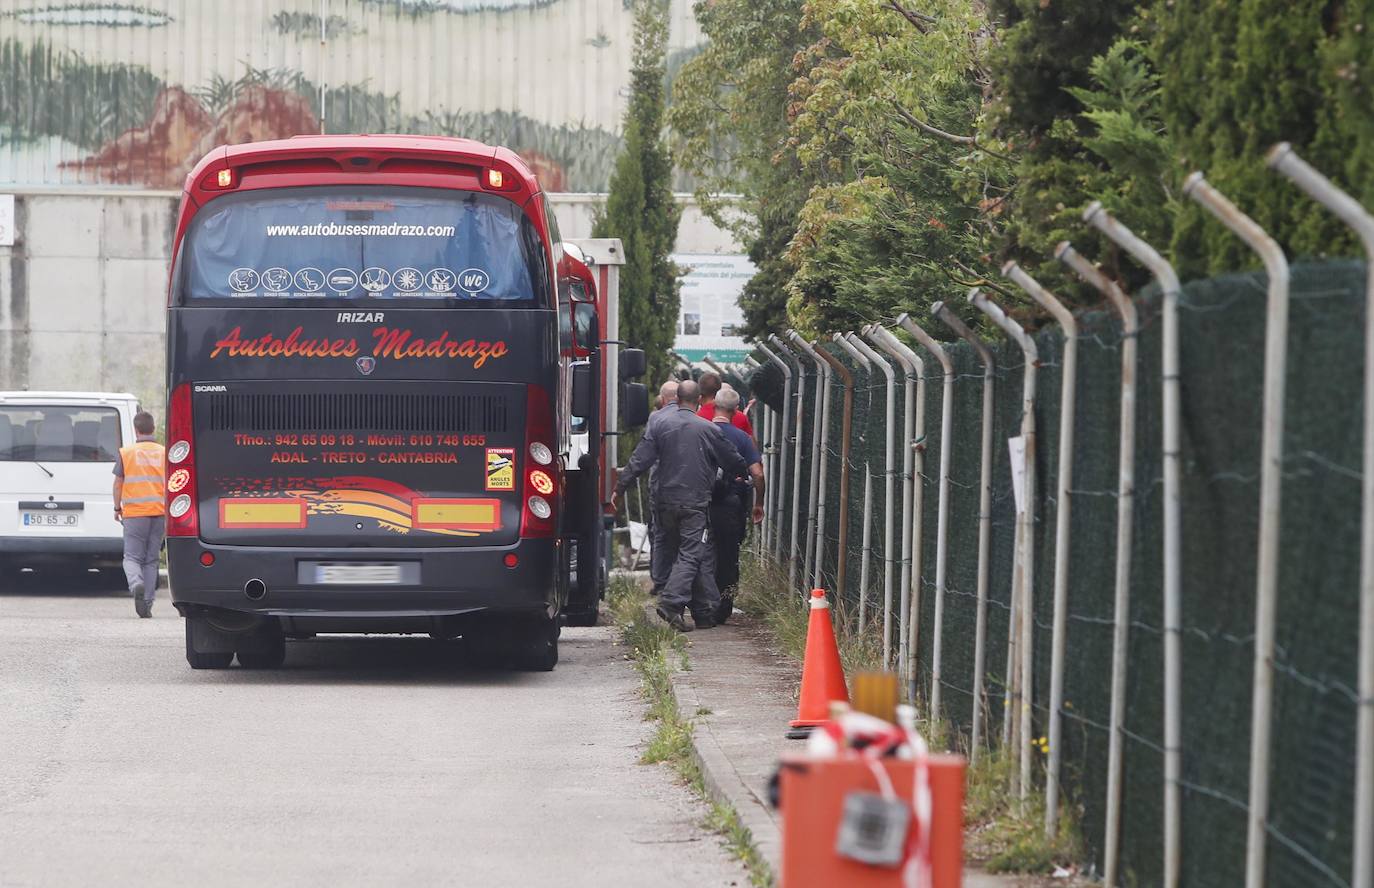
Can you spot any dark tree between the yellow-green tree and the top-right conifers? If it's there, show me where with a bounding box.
[988,0,1168,304]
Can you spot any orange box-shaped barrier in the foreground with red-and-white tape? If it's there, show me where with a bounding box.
[778,753,965,888]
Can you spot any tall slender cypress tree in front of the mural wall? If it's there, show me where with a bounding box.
[592,0,682,393]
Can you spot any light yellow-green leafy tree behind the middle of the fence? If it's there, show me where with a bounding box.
[787,0,1010,333]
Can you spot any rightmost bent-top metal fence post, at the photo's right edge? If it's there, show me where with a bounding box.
[1267,142,1374,888]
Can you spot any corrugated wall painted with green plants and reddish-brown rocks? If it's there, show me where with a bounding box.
[0,0,701,191]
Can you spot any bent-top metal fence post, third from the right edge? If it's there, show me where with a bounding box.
[1083,201,1183,888]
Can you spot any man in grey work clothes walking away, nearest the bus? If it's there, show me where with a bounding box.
[611,379,749,632]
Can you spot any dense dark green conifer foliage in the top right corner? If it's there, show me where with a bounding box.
[1154,0,1374,274]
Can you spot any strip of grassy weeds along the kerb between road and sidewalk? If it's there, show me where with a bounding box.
[607,577,774,888]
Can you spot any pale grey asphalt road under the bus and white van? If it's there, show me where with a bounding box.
[0,575,747,888]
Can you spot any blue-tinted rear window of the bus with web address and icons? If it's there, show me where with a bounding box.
[180,187,547,304]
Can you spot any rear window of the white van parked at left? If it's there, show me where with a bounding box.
[0,404,124,462]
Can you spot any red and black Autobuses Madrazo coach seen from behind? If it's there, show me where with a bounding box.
[166,136,647,669]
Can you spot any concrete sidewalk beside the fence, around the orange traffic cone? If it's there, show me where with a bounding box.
[672,614,1044,888]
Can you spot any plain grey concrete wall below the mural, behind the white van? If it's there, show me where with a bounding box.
[0,190,738,412]
